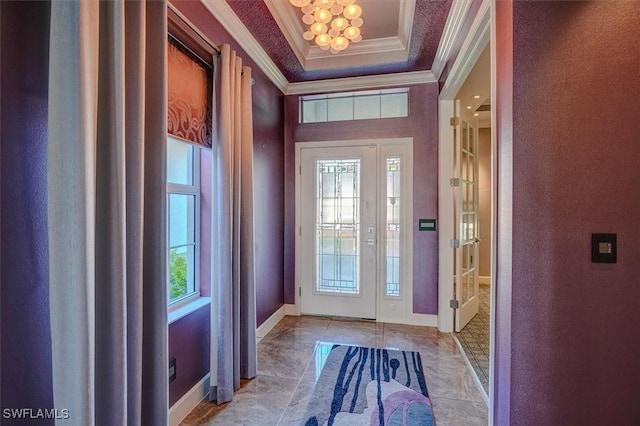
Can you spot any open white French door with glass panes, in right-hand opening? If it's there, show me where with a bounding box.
[453,101,480,331]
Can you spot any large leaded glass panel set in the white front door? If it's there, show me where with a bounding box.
[316,159,360,294]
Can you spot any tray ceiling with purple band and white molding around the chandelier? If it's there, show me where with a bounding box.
[202,0,470,94]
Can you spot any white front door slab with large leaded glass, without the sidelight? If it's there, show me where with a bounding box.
[298,145,377,318]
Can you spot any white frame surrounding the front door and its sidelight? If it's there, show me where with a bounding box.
[294,138,416,324]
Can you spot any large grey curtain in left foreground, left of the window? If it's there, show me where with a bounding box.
[47,0,168,425]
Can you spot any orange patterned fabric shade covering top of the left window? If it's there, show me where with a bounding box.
[167,38,213,146]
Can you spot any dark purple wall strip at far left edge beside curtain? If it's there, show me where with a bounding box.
[0,1,54,425]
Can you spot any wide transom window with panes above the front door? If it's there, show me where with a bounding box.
[300,89,409,123]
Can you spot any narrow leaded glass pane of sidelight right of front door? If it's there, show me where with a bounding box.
[385,157,401,297]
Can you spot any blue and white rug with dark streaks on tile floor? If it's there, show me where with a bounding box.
[303,345,435,426]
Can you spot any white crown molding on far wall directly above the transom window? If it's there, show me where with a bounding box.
[284,71,438,95]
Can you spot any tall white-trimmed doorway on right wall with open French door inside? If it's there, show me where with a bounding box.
[438,2,496,406]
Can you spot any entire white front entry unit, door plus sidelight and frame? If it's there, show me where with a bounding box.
[296,138,413,322]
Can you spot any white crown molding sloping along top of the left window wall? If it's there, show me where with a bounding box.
[202,0,289,93]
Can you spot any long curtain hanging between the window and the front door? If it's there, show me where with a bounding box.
[209,45,257,404]
